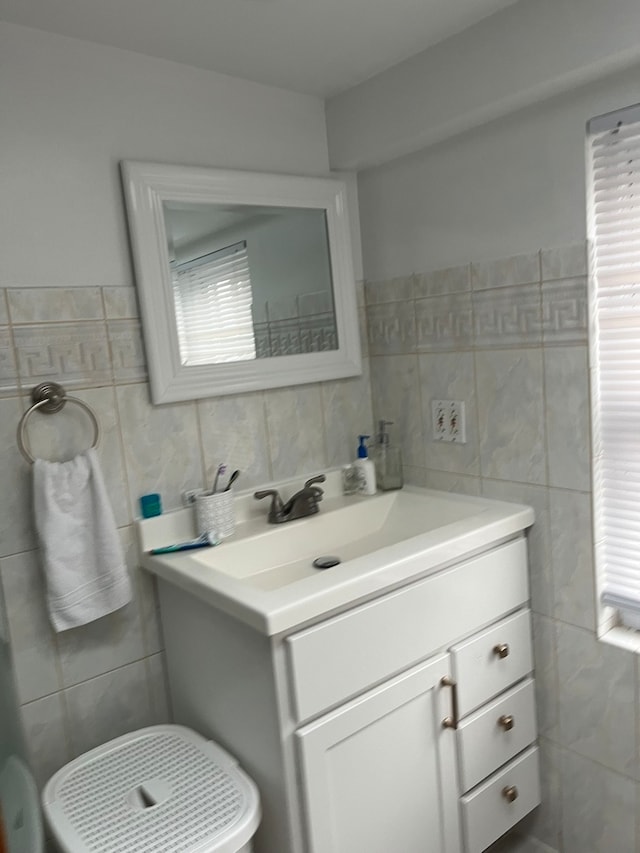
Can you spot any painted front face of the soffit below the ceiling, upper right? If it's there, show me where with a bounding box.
[327,0,640,169]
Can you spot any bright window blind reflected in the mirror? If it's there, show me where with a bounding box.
[172,241,256,365]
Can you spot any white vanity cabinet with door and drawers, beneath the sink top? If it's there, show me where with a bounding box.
[159,536,539,853]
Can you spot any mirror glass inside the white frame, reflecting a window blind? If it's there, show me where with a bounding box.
[162,201,338,365]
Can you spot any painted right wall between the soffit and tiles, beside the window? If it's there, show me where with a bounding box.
[359,66,640,280]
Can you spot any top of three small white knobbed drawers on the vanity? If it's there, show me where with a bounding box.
[451,604,533,717]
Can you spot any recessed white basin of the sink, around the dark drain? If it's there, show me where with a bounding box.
[193,491,478,590]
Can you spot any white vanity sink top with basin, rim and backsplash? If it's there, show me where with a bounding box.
[138,472,533,635]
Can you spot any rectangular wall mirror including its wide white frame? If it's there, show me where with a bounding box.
[122,161,361,404]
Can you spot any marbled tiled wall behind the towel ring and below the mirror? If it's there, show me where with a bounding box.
[0,287,373,783]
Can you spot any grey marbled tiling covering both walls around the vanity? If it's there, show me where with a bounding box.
[0,241,640,853]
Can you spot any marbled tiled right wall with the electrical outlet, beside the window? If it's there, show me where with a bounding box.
[366,245,640,853]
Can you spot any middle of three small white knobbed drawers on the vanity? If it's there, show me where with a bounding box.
[457,679,536,791]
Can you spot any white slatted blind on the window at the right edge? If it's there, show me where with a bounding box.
[587,105,640,628]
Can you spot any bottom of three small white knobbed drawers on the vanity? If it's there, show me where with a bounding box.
[461,747,540,853]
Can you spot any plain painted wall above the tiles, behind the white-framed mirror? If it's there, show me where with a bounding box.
[0,23,328,287]
